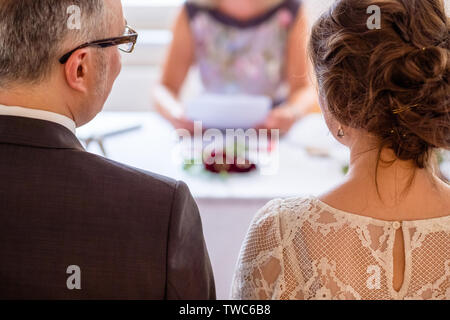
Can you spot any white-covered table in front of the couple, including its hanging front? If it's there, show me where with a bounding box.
[77,112,372,299]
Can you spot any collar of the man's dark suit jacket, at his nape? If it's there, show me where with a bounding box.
[0,115,85,151]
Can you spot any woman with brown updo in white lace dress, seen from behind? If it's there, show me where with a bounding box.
[232,0,450,299]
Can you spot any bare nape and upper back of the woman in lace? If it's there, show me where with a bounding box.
[347,141,450,215]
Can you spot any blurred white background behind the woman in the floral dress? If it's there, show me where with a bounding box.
[105,0,450,111]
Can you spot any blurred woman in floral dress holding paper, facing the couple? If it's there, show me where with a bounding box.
[155,0,317,132]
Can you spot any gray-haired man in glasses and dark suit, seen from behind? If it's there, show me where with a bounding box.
[0,0,215,299]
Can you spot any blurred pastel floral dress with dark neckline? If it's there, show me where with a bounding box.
[186,0,300,105]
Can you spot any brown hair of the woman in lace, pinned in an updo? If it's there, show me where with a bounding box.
[310,0,450,168]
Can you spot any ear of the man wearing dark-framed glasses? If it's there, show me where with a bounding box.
[64,48,90,93]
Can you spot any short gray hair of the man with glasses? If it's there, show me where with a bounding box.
[0,0,106,87]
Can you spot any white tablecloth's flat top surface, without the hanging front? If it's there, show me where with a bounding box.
[77,112,348,199]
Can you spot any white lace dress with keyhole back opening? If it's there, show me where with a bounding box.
[231,197,450,300]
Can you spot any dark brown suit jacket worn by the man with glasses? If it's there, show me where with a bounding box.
[0,116,215,299]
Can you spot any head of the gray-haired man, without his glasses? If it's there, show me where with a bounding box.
[0,0,125,126]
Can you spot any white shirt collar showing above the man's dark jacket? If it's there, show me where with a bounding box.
[0,104,77,134]
